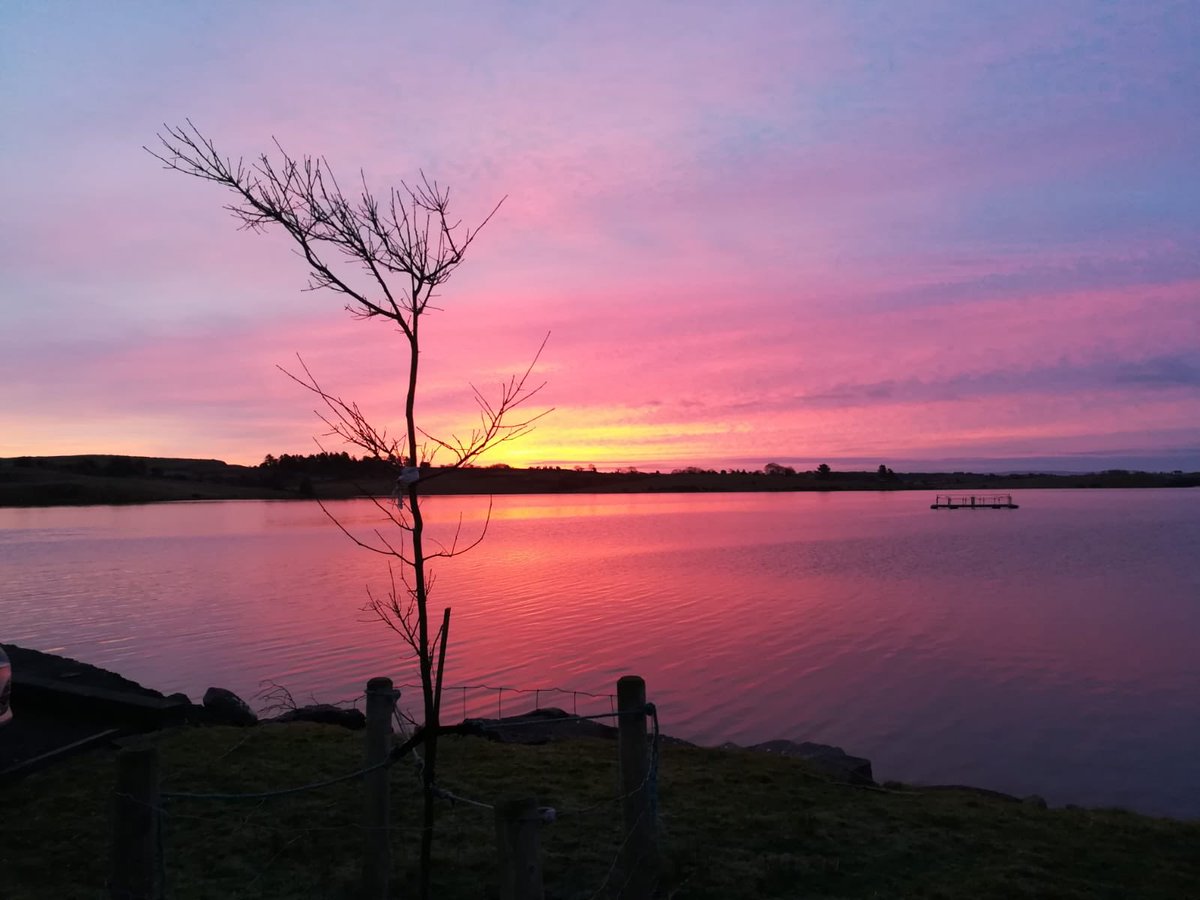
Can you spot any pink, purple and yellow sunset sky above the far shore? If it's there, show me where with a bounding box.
[0,0,1200,470]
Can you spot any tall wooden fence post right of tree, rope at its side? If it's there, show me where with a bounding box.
[617,676,659,900]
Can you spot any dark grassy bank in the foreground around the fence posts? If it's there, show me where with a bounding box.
[0,724,1200,900]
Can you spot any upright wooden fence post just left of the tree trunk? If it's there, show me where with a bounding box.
[362,678,396,900]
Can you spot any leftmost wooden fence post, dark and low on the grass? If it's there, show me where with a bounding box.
[108,746,162,900]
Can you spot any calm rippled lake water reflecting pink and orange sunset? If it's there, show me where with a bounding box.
[0,491,1200,816]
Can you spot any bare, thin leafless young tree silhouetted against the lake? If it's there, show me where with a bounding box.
[146,120,548,898]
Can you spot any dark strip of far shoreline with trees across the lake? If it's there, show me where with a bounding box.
[0,454,1200,508]
